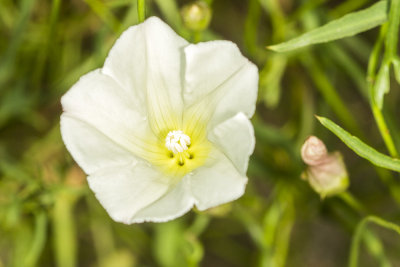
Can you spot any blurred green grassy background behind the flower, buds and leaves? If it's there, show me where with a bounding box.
[0,0,400,267]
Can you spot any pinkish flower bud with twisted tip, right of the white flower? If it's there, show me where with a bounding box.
[301,136,349,198]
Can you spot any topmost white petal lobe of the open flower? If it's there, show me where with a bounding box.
[103,17,188,131]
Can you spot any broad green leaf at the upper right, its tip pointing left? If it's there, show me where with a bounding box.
[267,1,387,52]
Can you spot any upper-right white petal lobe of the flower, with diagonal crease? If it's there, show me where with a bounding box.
[184,41,258,125]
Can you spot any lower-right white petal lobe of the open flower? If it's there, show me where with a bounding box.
[190,150,247,210]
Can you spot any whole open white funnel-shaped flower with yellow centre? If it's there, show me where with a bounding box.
[61,17,258,224]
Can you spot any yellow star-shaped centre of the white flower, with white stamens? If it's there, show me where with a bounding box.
[137,93,213,179]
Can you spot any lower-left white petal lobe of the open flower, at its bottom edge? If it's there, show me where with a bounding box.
[88,162,171,224]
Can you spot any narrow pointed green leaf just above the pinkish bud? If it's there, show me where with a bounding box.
[317,116,400,172]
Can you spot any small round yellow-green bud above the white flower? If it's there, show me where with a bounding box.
[181,1,211,31]
